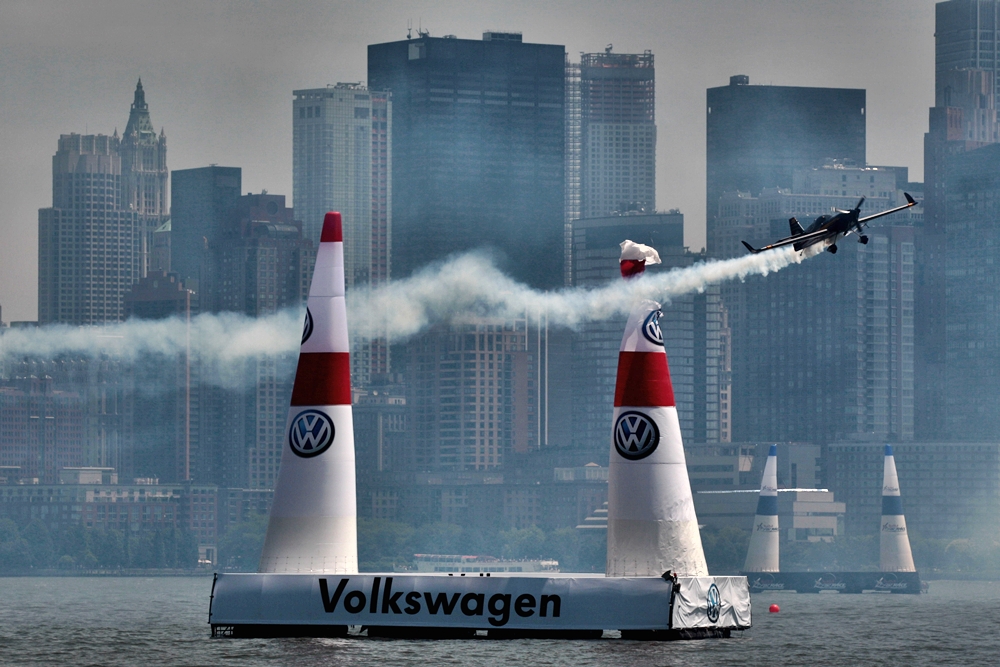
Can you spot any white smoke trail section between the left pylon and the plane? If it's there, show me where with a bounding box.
[348,246,804,341]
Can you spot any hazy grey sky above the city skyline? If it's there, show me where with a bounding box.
[0,0,934,321]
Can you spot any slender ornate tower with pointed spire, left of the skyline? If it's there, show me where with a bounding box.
[119,79,170,275]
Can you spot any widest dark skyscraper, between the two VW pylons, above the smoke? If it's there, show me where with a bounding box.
[368,32,565,287]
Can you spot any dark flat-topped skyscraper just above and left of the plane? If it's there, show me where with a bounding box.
[705,75,866,257]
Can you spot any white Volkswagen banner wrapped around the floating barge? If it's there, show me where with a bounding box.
[209,574,750,636]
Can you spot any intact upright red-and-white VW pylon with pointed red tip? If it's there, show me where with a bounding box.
[258,213,358,574]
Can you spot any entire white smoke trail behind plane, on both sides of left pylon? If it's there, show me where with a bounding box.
[0,248,804,378]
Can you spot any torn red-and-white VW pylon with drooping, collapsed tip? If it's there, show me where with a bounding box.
[606,241,708,577]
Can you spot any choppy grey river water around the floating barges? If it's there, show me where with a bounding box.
[0,577,1000,667]
